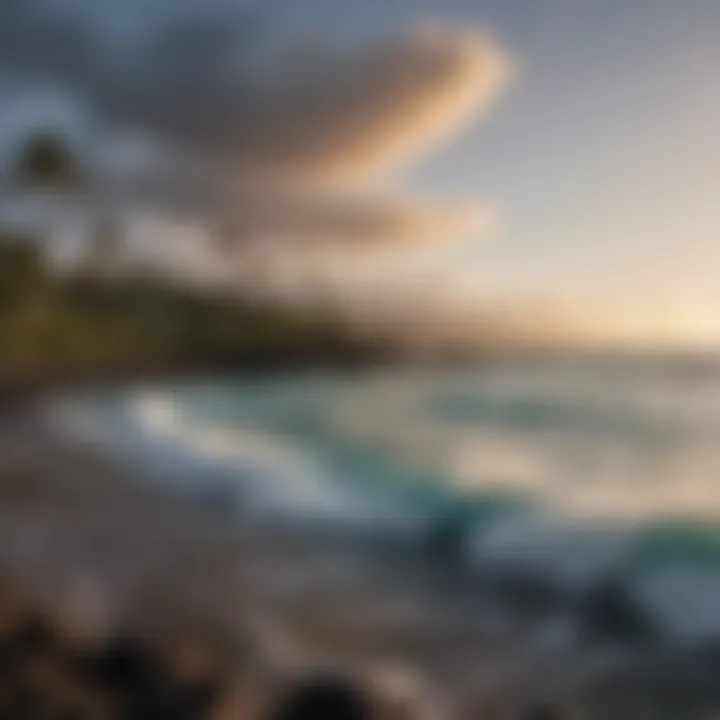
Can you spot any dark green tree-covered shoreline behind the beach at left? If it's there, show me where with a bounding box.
[0,237,376,378]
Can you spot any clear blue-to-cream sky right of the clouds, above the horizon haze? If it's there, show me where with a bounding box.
[316,0,720,298]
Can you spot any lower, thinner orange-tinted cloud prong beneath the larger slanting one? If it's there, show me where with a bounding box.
[116,170,492,252]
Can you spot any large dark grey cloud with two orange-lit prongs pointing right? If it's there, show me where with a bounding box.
[0,0,508,258]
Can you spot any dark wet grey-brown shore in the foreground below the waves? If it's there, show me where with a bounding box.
[0,404,720,720]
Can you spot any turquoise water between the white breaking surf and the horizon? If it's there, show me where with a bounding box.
[141,365,720,521]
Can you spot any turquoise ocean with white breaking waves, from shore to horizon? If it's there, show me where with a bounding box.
[52,357,720,641]
